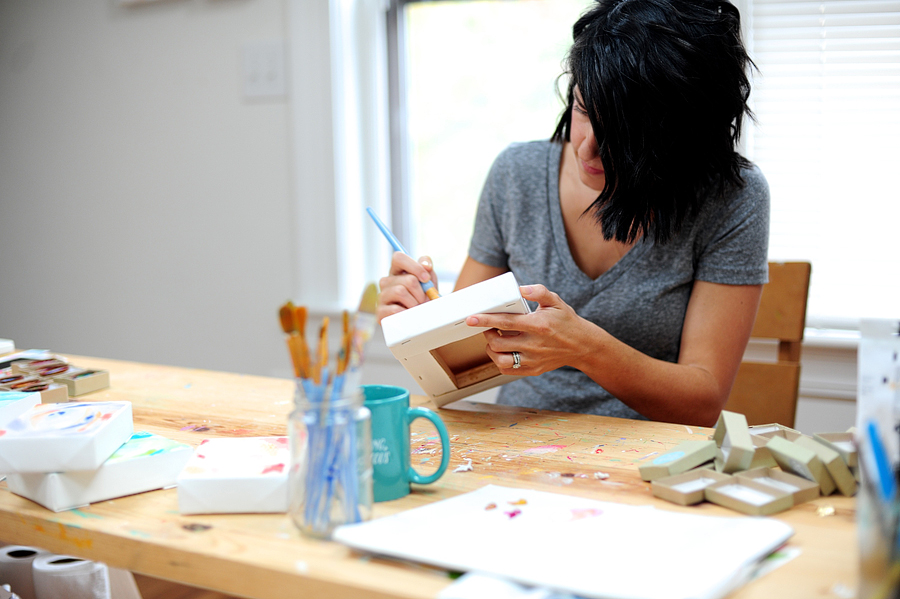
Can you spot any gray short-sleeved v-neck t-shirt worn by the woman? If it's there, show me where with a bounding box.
[469,141,769,419]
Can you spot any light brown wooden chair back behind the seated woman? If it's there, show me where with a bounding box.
[724,262,812,427]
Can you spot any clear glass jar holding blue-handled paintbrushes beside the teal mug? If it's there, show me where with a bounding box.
[288,381,372,538]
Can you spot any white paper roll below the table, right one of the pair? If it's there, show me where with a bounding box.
[32,554,112,599]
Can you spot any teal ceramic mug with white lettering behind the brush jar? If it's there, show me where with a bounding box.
[362,385,450,501]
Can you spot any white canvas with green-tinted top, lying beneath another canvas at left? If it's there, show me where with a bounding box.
[7,432,194,512]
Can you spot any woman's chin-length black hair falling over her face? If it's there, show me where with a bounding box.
[552,0,755,243]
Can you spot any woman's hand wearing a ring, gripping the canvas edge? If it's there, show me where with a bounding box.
[466,285,597,375]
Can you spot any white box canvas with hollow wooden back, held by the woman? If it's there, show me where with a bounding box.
[381,272,531,406]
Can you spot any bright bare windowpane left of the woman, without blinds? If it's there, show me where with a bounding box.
[393,0,593,284]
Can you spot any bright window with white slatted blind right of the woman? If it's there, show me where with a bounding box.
[745,0,900,328]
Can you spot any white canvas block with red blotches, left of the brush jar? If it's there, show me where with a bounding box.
[178,437,290,514]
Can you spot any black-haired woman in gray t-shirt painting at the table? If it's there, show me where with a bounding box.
[378,0,769,426]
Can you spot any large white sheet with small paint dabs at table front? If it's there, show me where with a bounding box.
[333,485,793,599]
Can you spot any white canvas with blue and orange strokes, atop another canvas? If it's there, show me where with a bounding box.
[0,401,134,474]
